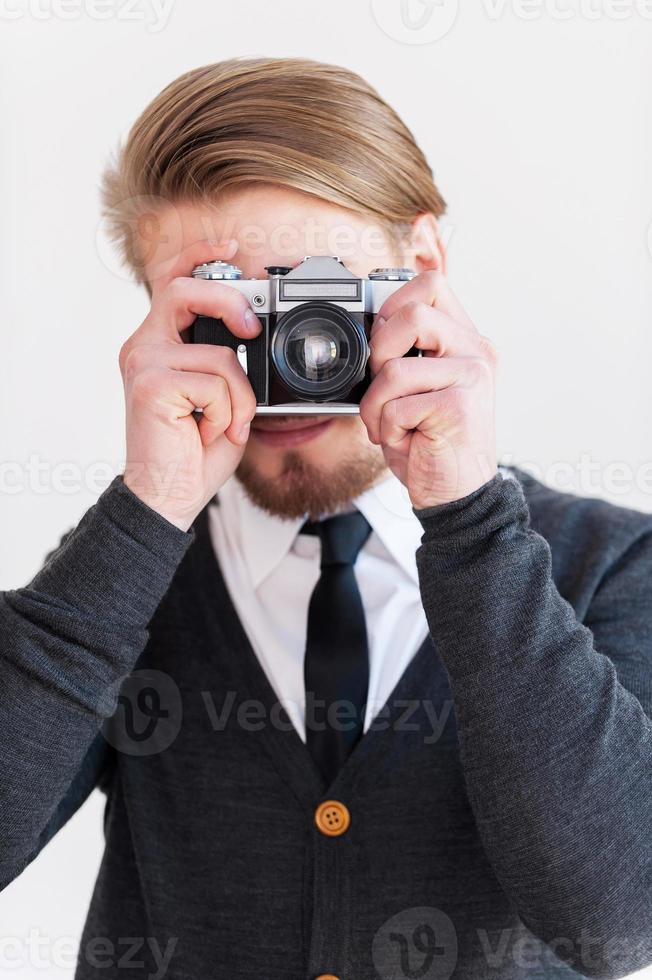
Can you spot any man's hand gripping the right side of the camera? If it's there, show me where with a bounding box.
[360,271,497,509]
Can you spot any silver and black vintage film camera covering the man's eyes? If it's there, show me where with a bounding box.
[190,255,416,415]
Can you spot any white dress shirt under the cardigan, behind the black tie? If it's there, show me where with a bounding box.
[209,476,428,741]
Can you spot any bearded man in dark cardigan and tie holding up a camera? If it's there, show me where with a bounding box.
[0,60,652,980]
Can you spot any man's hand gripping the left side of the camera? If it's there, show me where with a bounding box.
[120,241,261,531]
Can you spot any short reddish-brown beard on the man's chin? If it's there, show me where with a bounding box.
[235,445,387,520]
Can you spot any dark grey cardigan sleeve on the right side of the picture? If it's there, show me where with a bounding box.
[415,475,652,977]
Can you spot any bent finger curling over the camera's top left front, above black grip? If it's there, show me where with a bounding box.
[146,278,262,342]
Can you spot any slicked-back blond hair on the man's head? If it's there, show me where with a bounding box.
[102,58,446,279]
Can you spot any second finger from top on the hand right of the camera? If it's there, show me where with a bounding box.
[369,302,482,374]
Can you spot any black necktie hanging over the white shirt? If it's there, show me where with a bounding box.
[301,511,371,785]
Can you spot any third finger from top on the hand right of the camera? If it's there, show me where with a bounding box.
[360,357,488,444]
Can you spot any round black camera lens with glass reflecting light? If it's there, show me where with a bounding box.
[271,303,368,401]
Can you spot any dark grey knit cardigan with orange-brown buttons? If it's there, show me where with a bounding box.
[0,473,652,980]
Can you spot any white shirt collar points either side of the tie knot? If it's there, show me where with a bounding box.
[218,475,423,589]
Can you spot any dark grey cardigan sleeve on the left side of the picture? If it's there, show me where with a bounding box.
[0,478,193,888]
